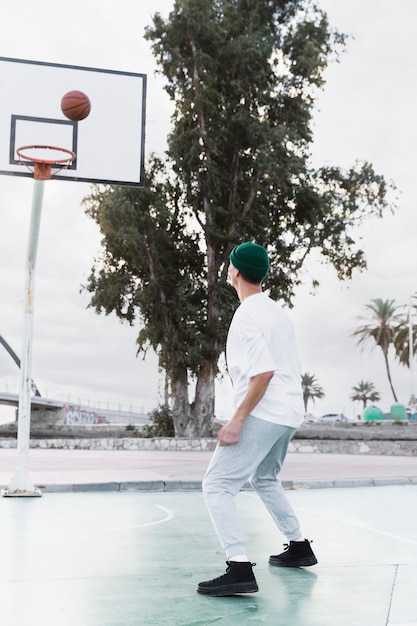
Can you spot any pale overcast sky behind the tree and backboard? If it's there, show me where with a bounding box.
[0,0,417,419]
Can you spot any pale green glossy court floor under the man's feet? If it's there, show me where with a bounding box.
[0,486,417,626]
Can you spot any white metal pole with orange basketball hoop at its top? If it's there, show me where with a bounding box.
[1,146,75,496]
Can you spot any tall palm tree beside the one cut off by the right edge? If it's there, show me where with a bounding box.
[352,298,402,402]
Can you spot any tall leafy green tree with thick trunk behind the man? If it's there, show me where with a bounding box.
[83,0,390,434]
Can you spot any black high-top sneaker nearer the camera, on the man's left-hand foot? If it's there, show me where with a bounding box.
[197,561,258,596]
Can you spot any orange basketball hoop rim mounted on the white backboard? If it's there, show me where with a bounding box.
[16,146,76,180]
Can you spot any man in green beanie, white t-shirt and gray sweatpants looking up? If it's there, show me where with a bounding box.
[197,242,317,596]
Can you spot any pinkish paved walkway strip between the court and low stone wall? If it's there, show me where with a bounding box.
[0,448,417,492]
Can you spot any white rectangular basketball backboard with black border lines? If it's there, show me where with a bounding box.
[0,57,146,186]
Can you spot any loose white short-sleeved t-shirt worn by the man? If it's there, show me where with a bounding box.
[226,293,304,428]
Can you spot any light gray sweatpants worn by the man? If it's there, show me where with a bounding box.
[203,416,301,559]
